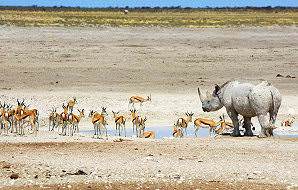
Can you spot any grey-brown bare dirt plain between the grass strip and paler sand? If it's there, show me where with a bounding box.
[0,27,298,95]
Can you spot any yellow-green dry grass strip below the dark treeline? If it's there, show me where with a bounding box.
[0,9,298,28]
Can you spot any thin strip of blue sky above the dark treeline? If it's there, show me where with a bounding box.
[0,0,298,7]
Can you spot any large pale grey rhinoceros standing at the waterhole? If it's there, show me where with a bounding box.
[198,81,282,137]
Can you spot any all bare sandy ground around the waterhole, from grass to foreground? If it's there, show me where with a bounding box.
[0,27,298,189]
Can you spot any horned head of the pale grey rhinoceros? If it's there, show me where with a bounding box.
[198,85,223,112]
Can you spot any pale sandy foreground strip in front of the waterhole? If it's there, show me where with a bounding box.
[0,137,298,188]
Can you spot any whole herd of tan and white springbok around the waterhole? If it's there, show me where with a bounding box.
[0,95,295,138]
